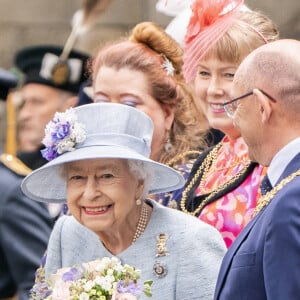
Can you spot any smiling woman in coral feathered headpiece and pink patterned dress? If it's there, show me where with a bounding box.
[180,0,278,247]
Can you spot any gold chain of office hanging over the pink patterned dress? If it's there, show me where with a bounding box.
[180,142,251,216]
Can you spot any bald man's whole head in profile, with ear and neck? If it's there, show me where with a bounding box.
[232,40,300,166]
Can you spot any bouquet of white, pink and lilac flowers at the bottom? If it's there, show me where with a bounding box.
[31,257,152,300]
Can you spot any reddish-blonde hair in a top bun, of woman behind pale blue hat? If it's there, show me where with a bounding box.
[93,22,206,163]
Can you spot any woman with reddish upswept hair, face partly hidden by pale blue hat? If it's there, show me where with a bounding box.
[91,22,207,208]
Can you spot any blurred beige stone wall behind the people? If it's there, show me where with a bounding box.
[0,0,300,68]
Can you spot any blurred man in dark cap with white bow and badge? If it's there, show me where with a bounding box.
[15,45,90,219]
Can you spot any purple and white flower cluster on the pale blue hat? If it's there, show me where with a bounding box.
[41,108,86,161]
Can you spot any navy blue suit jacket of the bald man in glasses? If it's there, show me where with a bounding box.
[214,154,300,300]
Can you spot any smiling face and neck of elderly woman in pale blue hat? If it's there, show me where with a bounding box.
[66,159,151,254]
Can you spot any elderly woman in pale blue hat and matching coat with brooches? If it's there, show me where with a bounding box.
[22,103,226,300]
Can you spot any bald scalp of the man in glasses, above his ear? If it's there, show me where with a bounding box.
[234,39,300,112]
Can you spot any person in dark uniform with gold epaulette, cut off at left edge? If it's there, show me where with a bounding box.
[0,69,52,300]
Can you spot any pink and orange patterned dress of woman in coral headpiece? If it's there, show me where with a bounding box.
[195,137,266,247]
